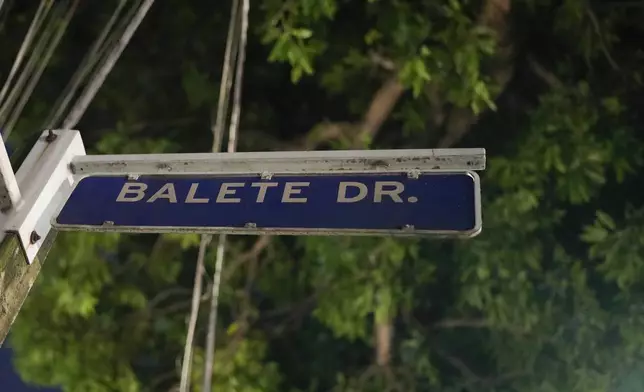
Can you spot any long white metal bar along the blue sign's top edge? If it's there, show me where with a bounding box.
[71,148,485,176]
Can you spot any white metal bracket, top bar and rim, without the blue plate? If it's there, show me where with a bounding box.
[0,130,486,262]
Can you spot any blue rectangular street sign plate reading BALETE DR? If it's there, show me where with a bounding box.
[54,172,481,236]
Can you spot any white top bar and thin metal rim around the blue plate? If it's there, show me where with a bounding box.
[52,148,486,238]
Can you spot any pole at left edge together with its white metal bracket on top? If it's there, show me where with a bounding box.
[0,131,85,344]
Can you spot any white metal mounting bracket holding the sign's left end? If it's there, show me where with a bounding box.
[0,130,85,264]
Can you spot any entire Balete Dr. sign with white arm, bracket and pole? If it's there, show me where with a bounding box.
[0,130,485,356]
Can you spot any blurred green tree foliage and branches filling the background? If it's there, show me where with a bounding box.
[0,0,644,392]
